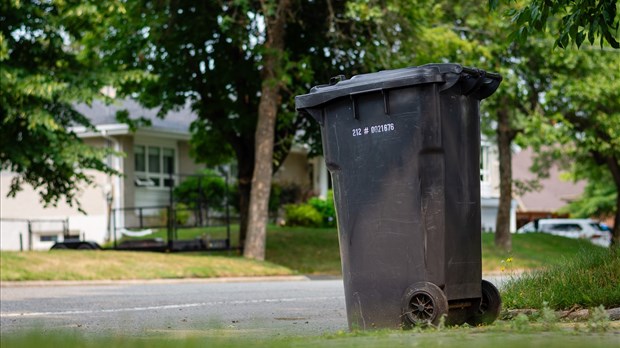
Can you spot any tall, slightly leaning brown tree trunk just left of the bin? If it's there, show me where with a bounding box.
[243,0,291,260]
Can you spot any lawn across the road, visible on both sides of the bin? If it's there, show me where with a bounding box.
[0,226,601,280]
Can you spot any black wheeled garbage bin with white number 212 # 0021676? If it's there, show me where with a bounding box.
[295,64,501,329]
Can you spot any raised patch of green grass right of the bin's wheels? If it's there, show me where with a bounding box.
[502,248,620,310]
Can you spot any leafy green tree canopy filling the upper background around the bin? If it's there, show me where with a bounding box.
[0,0,620,253]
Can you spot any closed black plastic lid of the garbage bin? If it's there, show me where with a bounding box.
[295,64,501,110]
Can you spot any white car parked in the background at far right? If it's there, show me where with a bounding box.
[517,219,611,247]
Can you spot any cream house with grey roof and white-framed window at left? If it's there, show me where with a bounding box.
[0,100,200,250]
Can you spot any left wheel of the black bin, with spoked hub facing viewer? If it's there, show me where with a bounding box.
[402,282,448,326]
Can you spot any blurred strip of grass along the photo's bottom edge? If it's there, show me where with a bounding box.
[1,328,618,348]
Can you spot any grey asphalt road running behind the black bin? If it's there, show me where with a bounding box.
[0,277,502,337]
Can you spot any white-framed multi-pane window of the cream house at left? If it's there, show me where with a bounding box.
[134,145,175,188]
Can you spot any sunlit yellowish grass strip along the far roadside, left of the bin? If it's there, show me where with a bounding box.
[0,250,293,281]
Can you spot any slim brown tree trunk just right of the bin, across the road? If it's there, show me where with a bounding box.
[495,103,514,251]
